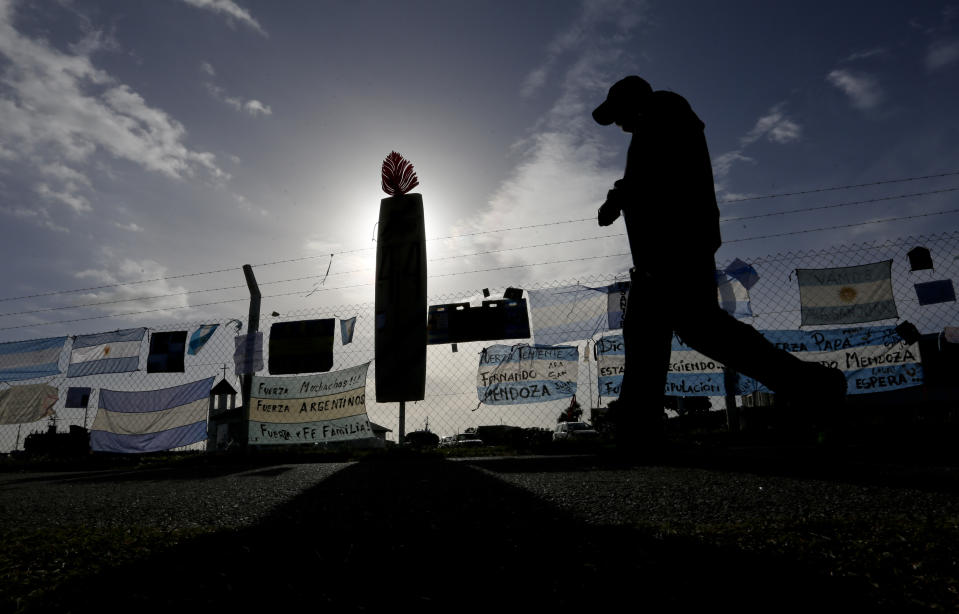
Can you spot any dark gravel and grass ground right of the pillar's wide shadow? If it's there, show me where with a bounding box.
[469,449,959,612]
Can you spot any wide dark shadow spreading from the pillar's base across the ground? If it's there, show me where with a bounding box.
[28,460,869,614]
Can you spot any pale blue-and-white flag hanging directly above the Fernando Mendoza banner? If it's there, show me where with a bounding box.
[527,285,609,345]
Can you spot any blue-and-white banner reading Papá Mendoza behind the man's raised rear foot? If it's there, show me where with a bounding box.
[737,326,923,394]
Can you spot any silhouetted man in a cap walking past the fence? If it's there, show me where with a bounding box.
[593,76,846,443]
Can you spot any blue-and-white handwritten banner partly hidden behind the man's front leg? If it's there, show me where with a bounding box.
[596,335,726,397]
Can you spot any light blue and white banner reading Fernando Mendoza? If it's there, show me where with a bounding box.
[476,344,576,405]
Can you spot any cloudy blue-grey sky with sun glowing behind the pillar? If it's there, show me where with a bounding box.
[0,0,959,341]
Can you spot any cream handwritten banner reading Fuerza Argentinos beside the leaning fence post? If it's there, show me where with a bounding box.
[250,363,373,444]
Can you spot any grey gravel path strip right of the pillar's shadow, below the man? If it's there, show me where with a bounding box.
[473,459,959,526]
